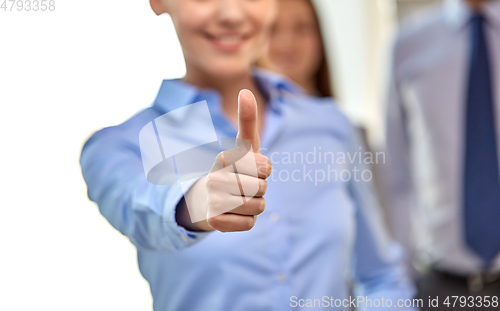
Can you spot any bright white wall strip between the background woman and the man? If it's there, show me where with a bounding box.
[314,0,397,144]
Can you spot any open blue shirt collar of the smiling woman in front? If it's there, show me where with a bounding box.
[153,68,305,117]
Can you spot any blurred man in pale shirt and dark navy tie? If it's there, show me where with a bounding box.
[386,0,500,310]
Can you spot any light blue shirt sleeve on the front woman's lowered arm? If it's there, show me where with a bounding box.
[349,132,417,311]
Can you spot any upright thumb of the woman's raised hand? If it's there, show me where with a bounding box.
[236,89,260,153]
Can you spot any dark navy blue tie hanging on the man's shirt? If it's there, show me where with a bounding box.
[464,15,500,265]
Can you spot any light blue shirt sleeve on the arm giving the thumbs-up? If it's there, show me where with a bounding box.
[80,129,209,252]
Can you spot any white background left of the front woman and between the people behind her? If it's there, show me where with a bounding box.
[0,0,438,311]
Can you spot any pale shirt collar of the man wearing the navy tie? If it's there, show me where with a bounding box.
[443,0,500,31]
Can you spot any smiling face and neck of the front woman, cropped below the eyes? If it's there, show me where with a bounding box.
[151,0,276,85]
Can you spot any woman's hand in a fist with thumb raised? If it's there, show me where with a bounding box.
[205,90,272,232]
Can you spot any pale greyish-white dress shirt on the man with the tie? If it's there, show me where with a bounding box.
[385,0,500,275]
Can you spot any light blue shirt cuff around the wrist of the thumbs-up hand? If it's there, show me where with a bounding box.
[163,179,210,250]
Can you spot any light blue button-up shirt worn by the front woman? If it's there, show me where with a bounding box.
[81,70,413,311]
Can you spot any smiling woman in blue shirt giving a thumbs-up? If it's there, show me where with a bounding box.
[80,0,413,311]
